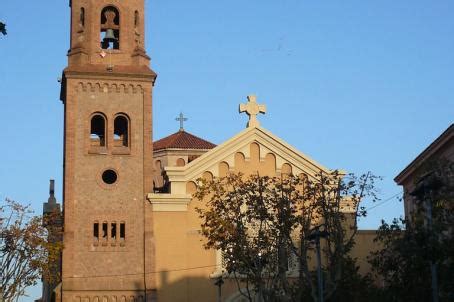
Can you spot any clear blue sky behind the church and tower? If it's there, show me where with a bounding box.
[0,0,454,301]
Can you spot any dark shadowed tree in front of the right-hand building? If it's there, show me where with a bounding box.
[370,160,454,301]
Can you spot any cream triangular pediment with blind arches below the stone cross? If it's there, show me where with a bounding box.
[165,127,331,183]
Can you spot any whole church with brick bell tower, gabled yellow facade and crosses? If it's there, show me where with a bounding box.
[51,0,369,302]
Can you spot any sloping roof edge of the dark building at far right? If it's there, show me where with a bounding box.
[394,124,454,185]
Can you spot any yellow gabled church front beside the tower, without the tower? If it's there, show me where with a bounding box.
[147,119,340,301]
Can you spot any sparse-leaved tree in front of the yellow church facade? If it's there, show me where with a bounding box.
[195,171,377,301]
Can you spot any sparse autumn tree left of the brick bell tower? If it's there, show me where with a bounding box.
[0,199,62,302]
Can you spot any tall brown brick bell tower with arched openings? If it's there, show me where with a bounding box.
[57,0,156,302]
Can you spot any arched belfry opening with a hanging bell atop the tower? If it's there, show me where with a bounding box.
[101,6,120,49]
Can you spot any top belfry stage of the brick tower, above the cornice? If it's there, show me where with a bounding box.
[68,0,150,66]
